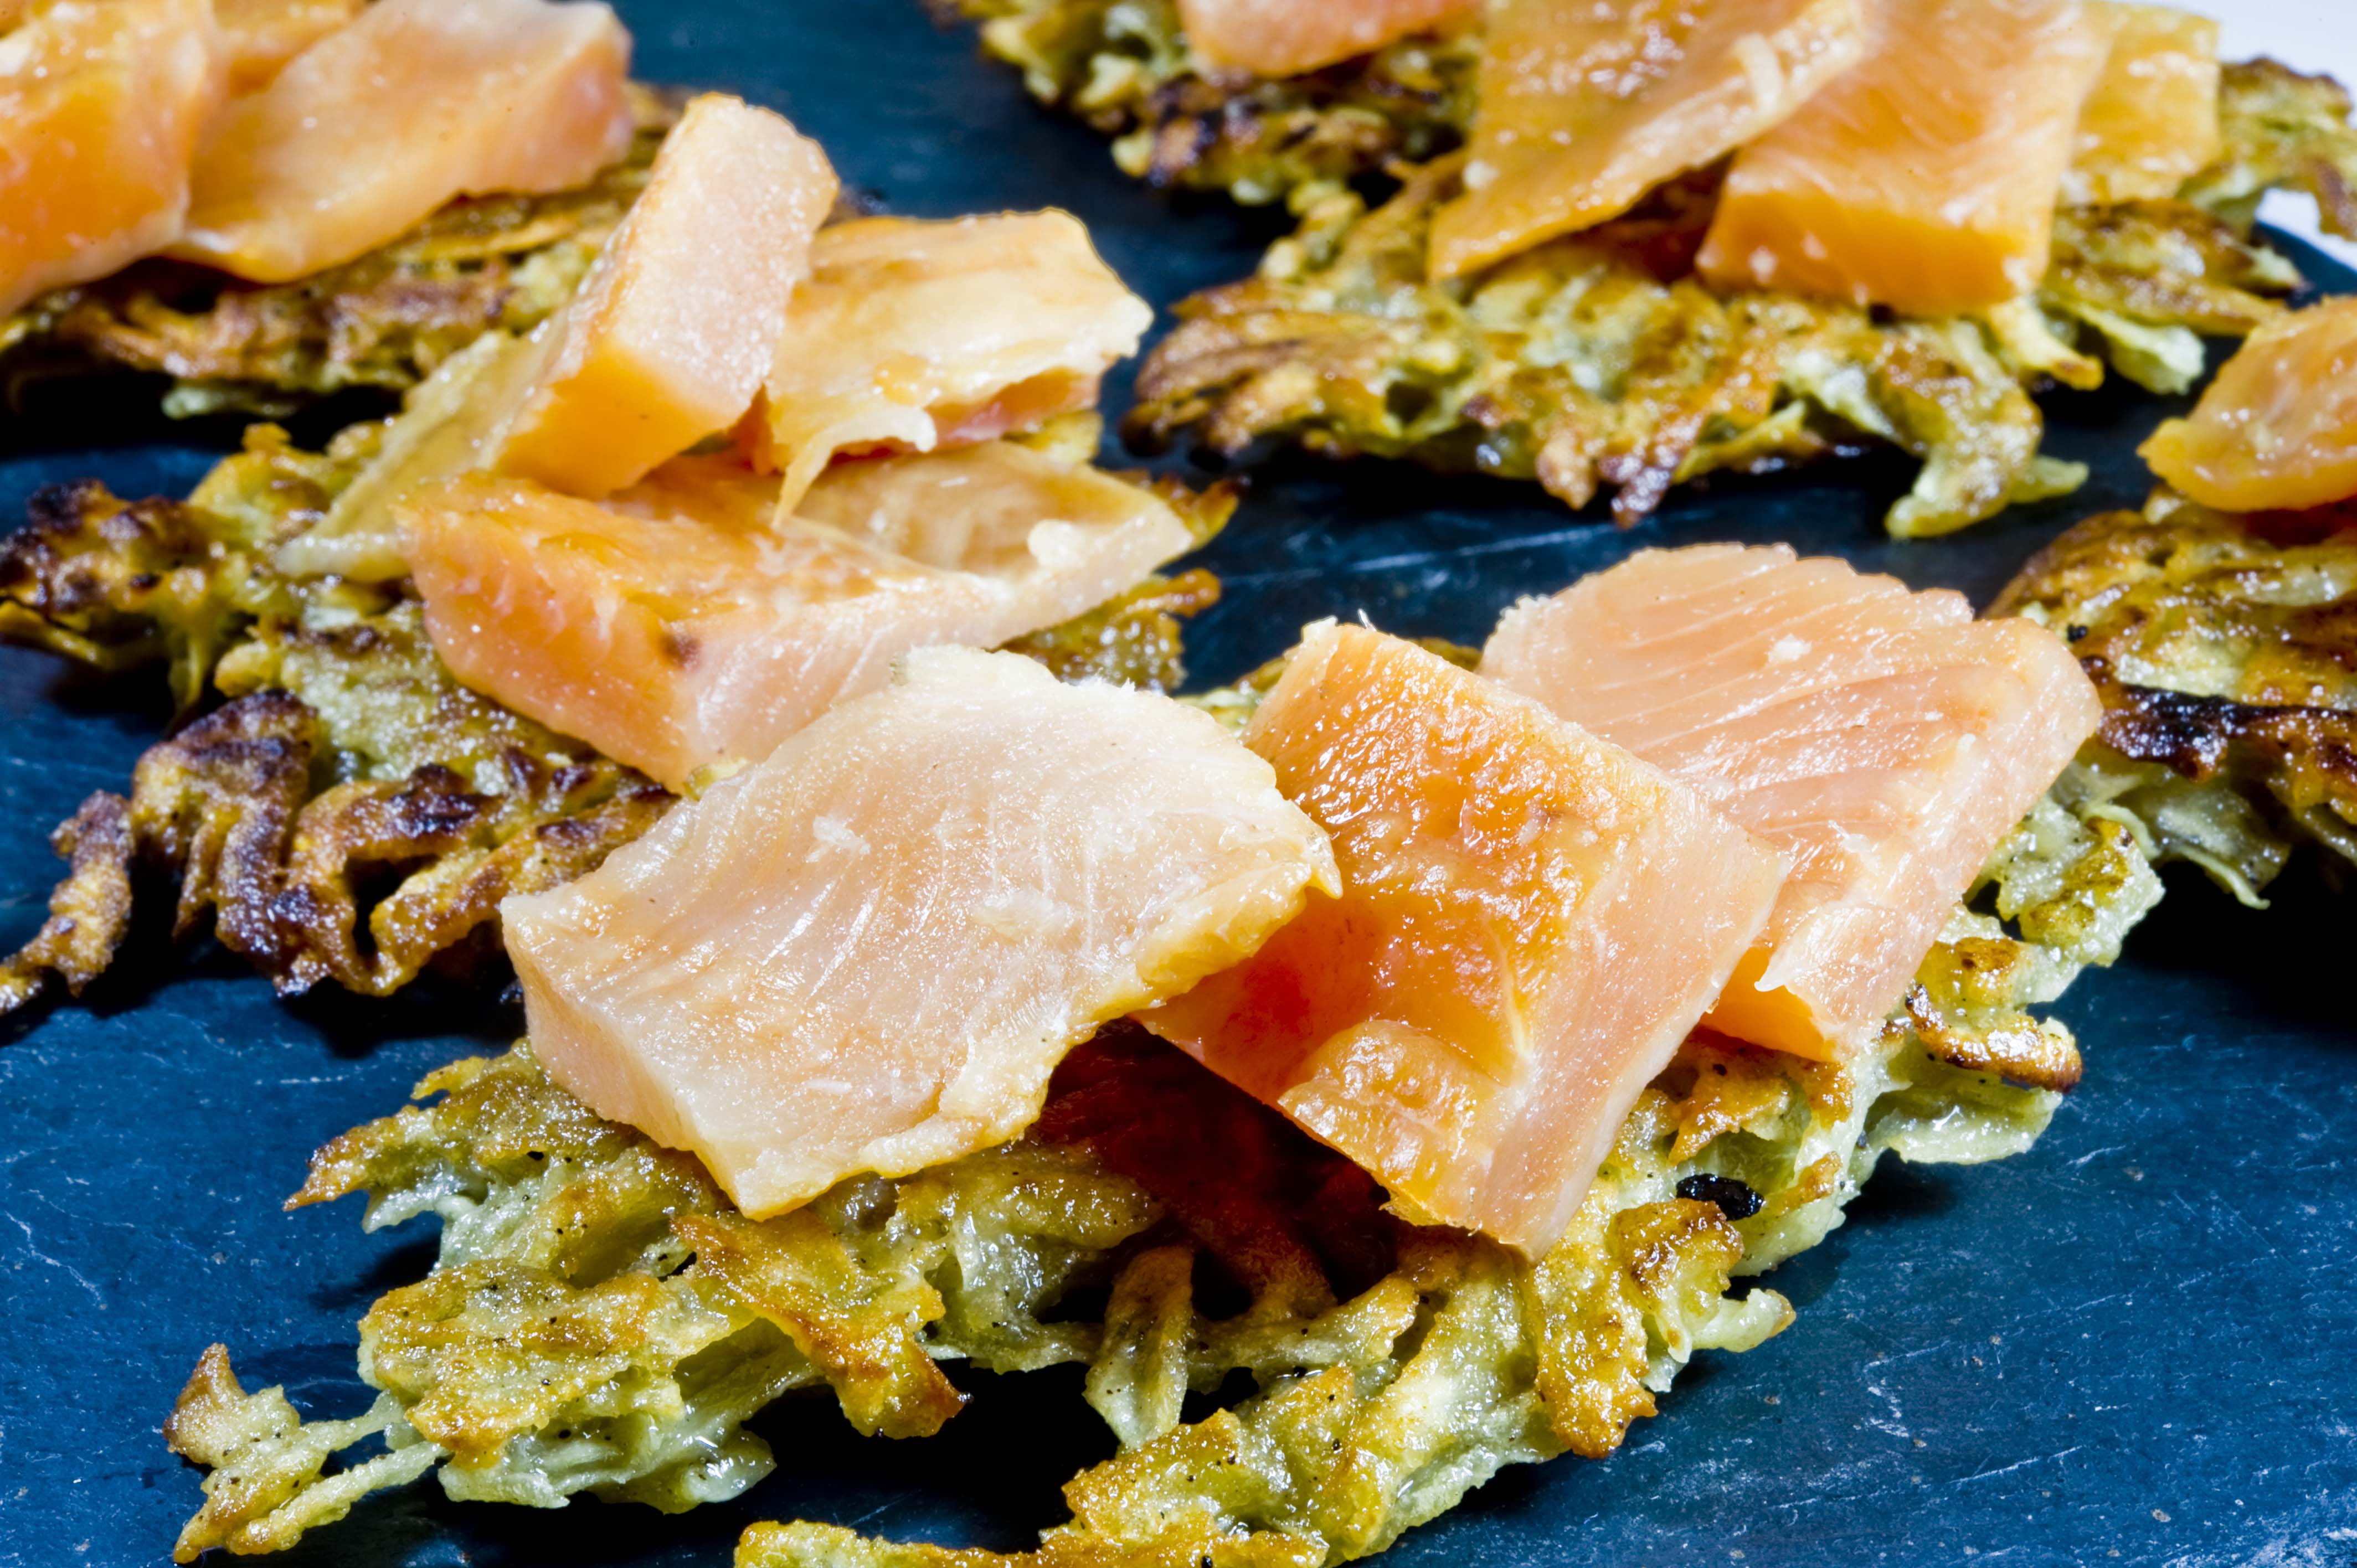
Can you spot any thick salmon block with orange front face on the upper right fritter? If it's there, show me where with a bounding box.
[1697,0,2107,316]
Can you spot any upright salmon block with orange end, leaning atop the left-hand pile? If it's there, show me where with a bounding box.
[495,94,837,498]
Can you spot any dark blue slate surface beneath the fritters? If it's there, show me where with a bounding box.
[0,0,2357,1568]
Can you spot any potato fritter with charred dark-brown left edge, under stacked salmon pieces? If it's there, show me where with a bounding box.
[0,422,1235,1014]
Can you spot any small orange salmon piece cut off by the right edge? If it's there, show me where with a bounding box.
[2135,297,2357,512]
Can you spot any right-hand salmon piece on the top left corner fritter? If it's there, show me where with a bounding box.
[172,0,632,283]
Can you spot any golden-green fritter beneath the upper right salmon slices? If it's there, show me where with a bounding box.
[1129,158,2296,535]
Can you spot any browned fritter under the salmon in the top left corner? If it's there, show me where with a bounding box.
[0,87,679,415]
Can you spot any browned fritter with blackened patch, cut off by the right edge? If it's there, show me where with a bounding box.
[1996,491,2357,903]
